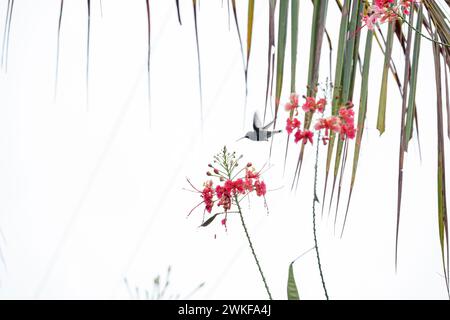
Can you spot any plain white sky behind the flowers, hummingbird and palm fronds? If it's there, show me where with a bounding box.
[0,0,449,299]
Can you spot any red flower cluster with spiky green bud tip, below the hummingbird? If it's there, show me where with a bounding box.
[188,148,267,226]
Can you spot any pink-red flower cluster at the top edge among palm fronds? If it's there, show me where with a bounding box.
[362,0,419,30]
